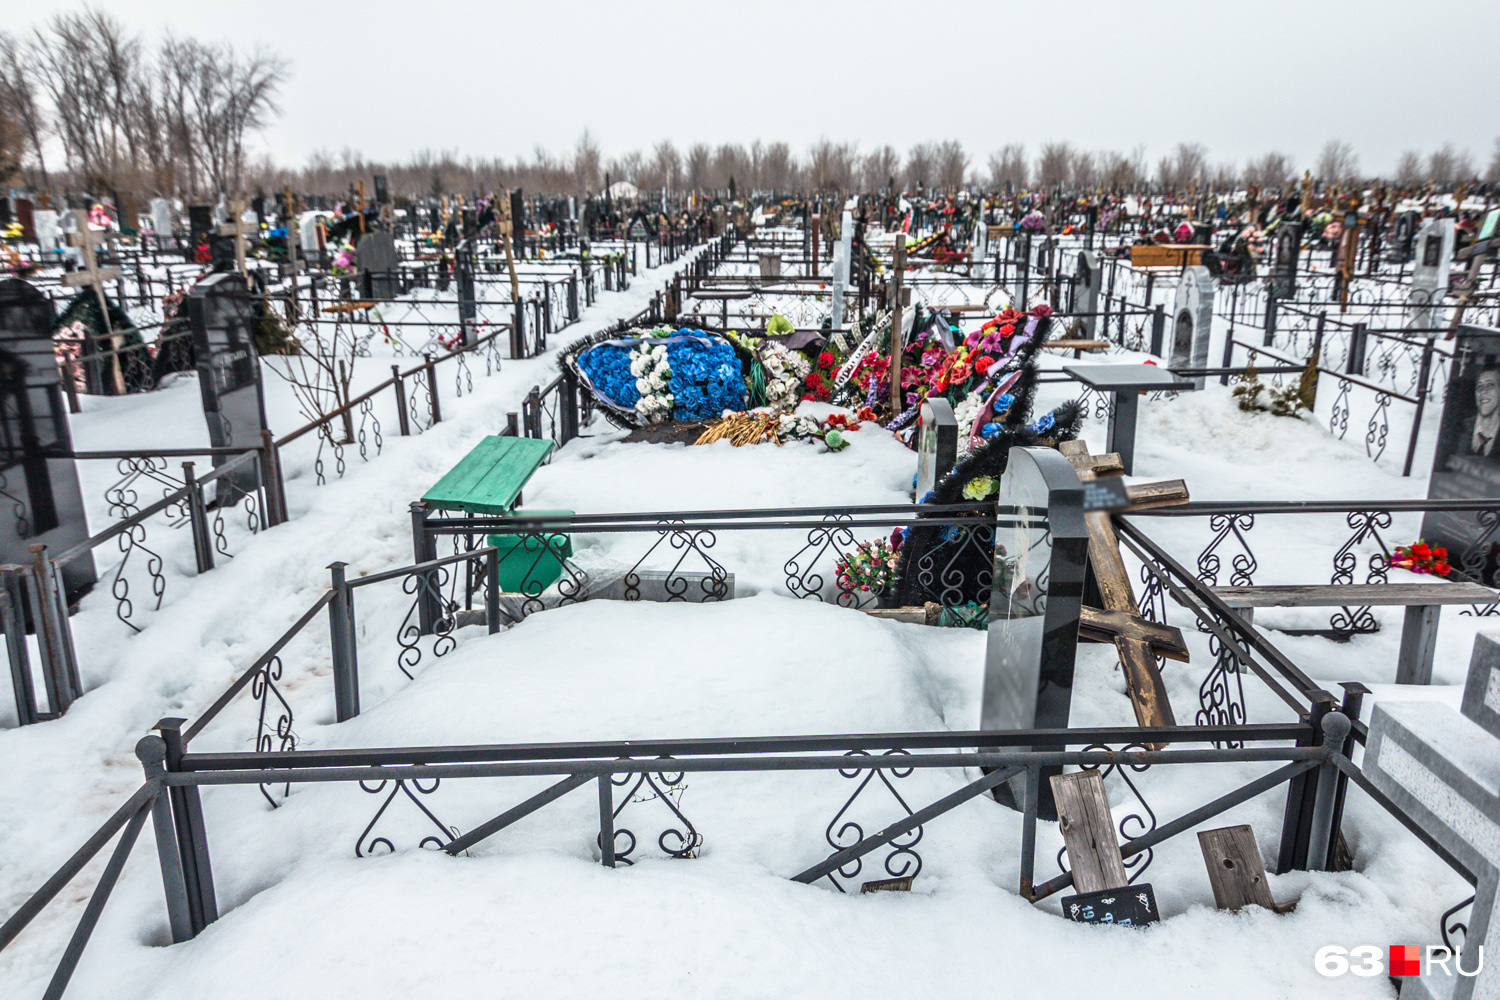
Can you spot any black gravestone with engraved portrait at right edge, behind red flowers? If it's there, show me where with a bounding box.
[1422,325,1500,586]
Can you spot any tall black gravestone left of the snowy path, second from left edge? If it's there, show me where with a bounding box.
[188,271,266,504]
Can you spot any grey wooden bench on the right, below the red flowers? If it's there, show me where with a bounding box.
[1209,583,1497,684]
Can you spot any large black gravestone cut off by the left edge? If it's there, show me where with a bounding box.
[0,277,98,603]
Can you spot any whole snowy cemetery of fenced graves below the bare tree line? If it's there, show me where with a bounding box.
[0,7,1500,1000]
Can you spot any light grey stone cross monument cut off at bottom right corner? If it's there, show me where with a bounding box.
[1362,634,1500,1000]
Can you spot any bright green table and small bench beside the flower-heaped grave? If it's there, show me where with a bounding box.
[422,435,573,594]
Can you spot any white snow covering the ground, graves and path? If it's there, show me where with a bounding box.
[0,244,1484,999]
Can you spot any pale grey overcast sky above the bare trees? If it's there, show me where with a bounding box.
[17,0,1500,172]
